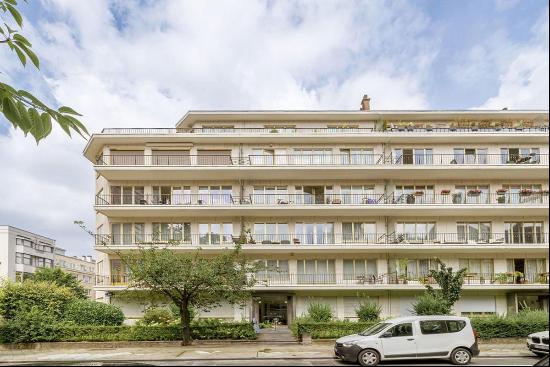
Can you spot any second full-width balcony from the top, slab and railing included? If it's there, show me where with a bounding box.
[95,190,548,217]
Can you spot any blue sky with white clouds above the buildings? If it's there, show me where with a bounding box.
[0,0,549,255]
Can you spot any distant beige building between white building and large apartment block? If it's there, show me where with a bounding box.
[54,247,95,299]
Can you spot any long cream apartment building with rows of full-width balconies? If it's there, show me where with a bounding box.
[84,97,549,322]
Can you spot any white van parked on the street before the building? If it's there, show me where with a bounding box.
[334,316,479,366]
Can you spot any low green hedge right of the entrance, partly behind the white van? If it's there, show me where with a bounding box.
[290,319,376,339]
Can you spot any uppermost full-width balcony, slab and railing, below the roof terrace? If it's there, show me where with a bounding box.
[95,154,548,180]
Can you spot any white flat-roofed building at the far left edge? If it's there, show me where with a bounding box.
[0,225,55,280]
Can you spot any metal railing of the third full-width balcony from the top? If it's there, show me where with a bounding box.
[95,232,548,248]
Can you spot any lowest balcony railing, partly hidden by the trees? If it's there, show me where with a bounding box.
[96,272,548,287]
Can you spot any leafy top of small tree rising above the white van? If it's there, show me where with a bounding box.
[426,258,468,308]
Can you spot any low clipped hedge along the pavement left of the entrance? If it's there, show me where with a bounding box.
[0,322,256,343]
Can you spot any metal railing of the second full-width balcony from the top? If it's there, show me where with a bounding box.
[95,191,548,207]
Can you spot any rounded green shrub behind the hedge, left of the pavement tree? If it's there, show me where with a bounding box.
[64,299,124,325]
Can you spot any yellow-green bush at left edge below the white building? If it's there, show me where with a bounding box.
[0,280,75,320]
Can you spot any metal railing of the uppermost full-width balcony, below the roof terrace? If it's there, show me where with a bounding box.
[96,153,548,167]
